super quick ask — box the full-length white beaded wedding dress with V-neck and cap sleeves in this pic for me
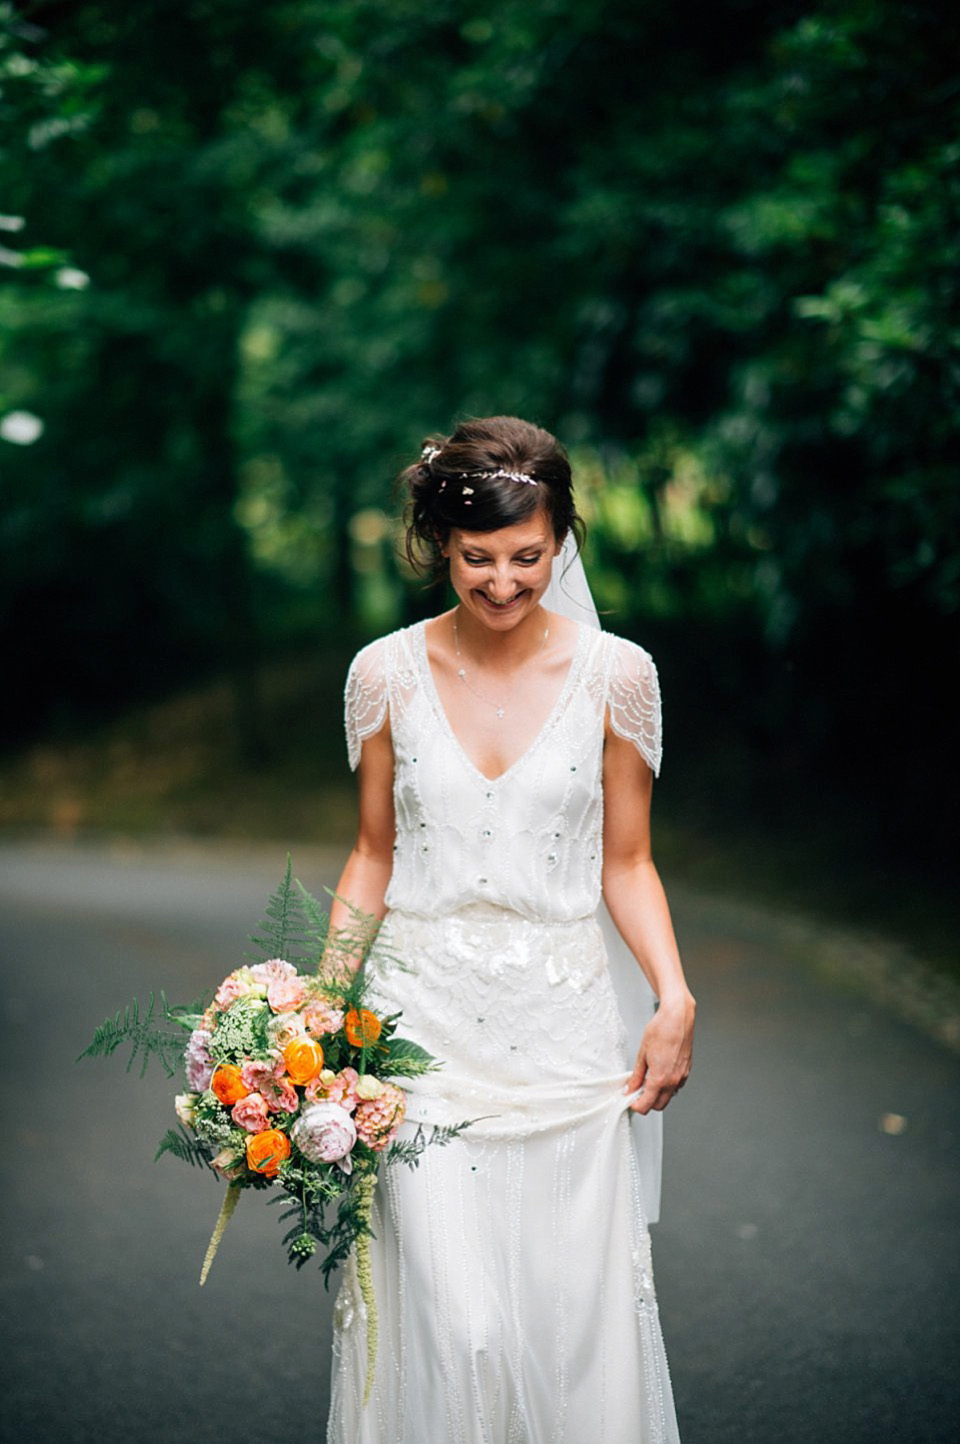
[328,622,678,1444]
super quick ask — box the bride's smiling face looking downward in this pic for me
[443,511,560,631]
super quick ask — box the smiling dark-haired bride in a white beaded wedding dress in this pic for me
[329,417,694,1444]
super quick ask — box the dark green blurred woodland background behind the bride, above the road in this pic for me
[0,0,960,959]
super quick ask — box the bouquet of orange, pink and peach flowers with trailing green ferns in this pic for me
[81,858,468,1395]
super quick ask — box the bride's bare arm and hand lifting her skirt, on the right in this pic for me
[603,728,696,1113]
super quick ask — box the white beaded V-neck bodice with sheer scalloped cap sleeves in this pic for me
[345,622,661,923]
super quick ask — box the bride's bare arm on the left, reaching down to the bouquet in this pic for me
[331,721,396,972]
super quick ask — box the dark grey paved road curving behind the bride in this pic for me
[0,846,960,1444]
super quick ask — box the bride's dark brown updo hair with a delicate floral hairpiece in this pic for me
[397,416,586,575]
